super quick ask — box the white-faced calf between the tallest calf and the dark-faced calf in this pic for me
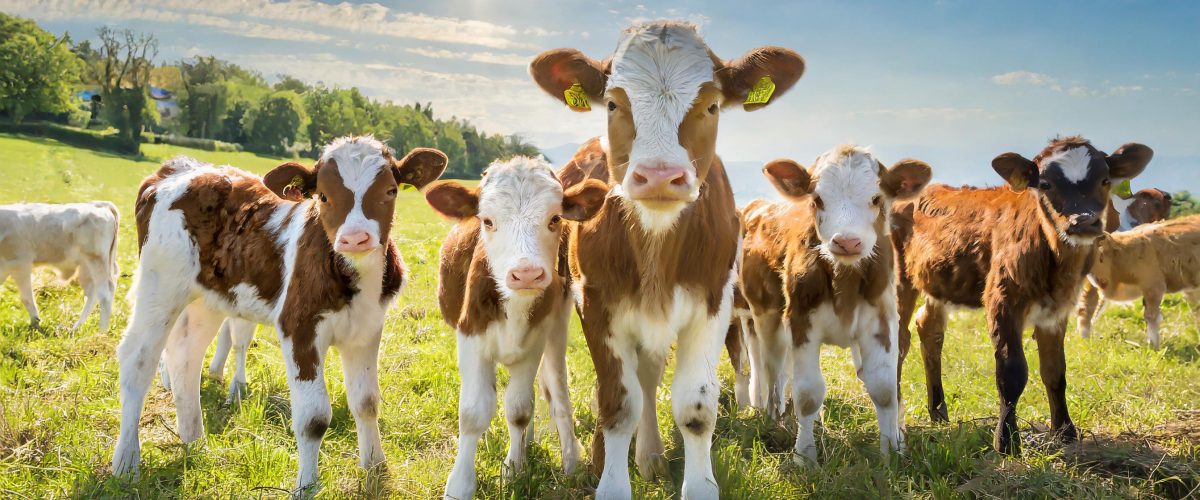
[740,145,932,460]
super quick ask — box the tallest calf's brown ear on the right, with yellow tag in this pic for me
[716,46,804,112]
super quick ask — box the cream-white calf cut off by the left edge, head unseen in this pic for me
[0,201,120,331]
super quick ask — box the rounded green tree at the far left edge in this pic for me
[0,12,82,124]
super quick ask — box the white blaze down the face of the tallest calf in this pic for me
[608,23,714,165]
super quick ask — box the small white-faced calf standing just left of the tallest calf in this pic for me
[425,157,608,499]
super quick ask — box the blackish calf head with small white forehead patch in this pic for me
[991,137,1154,245]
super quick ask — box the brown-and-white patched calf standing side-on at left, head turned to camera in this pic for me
[113,137,446,488]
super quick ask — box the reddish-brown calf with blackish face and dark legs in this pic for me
[894,137,1153,453]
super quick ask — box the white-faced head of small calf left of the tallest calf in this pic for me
[425,157,608,296]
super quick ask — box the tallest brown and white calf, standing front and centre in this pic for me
[529,22,804,499]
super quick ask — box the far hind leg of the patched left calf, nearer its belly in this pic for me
[166,300,223,444]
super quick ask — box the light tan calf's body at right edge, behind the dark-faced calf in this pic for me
[1078,216,1200,349]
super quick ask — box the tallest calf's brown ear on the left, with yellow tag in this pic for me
[529,49,608,112]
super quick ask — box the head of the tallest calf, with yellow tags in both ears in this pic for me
[529,20,804,231]
